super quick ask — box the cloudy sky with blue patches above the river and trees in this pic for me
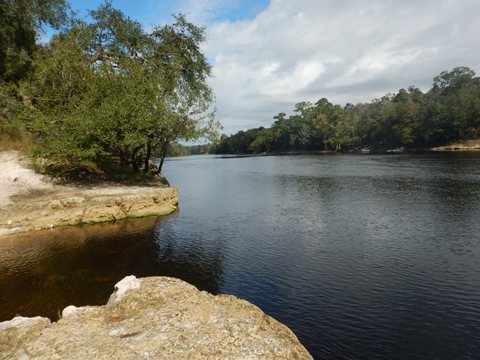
[66,0,480,134]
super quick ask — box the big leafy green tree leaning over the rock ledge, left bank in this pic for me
[21,3,218,172]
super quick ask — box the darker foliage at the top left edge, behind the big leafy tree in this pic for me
[0,0,69,152]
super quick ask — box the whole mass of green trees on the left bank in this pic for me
[0,0,219,172]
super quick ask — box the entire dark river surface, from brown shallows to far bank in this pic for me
[0,154,480,359]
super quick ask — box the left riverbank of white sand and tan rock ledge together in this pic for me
[0,152,178,236]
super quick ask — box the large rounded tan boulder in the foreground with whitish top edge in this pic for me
[0,276,312,359]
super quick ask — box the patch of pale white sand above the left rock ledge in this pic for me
[0,151,54,207]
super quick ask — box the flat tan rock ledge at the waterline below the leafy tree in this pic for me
[0,186,178,236]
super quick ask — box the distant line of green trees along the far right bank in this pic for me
[212,67,480,154]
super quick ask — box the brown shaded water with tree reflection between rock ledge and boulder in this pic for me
[0,218,222,321]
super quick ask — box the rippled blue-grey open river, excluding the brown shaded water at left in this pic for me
[166,154,480,359]
